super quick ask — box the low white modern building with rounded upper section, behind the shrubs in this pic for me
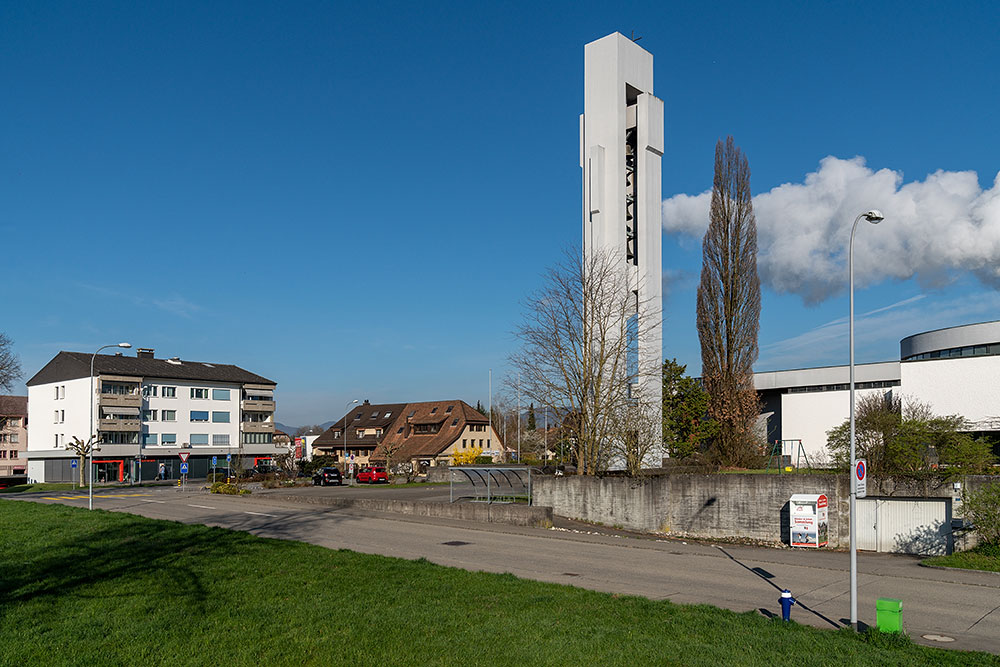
[754,321,1000,465]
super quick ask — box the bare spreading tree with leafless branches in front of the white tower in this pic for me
[508,251,661,474]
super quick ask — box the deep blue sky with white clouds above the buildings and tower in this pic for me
[0,2,1000,424]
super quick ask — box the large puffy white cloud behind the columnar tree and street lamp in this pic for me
[662,156,1000,303]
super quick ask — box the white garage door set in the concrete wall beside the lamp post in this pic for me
[858,498,953,555]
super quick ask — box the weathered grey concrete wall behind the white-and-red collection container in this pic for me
[532,474,997,547]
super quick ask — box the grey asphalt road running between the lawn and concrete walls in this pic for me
[9,486,1000,653]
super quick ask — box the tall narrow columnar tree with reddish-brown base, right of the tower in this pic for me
[697,137,760,466]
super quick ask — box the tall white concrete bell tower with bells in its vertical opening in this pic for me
[580,32,663,454]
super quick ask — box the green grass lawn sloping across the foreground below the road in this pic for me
[0,501,1000,666]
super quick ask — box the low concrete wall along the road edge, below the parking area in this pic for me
[267,493,552,528]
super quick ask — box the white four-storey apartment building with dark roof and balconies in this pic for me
[27,348,284,482]
